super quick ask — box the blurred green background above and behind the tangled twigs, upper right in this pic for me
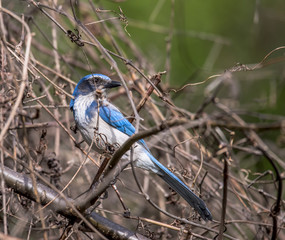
[96,0,285,115]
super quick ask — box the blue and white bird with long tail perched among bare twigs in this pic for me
[70,73,212,221]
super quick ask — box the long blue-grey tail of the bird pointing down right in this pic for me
[149,154,212,221]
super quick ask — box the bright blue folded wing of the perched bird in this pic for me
[99,104,149,151]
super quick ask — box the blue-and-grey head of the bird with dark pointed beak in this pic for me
[69,74,121,109]
